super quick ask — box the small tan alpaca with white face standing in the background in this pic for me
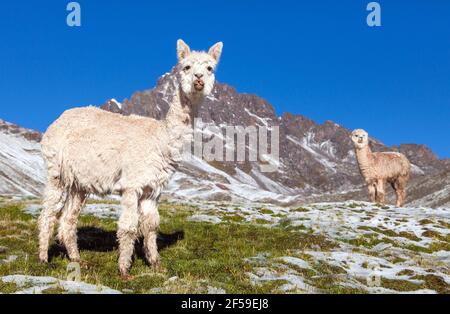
[351,129,411,207]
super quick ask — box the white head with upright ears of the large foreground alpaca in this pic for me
[177,39,223,101]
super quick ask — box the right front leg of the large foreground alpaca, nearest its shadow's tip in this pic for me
[140,198,160,267]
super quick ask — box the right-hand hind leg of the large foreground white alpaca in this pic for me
[58,191,86,262]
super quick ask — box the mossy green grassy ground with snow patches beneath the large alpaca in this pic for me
[0,199,450,293]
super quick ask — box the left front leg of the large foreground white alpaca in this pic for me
[117,191,139,277]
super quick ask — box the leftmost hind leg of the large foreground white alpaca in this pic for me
[38,180,67,263]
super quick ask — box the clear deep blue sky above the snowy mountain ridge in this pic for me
[0,0,450,157]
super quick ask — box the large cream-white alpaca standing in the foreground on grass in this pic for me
[39,40,223,278]
